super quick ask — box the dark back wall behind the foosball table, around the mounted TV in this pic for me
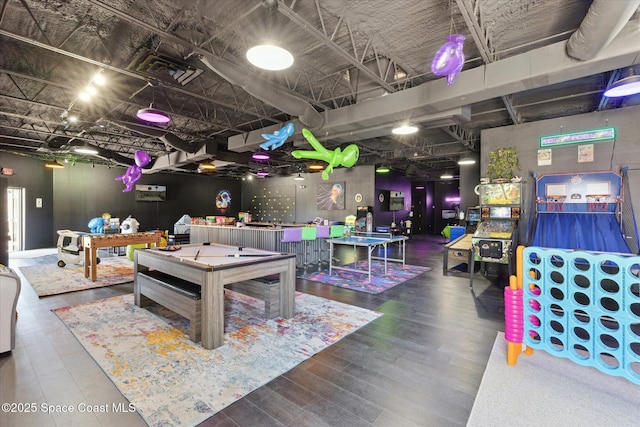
[53,164,242,239]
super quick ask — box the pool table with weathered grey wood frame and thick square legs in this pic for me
[134,243,296,350]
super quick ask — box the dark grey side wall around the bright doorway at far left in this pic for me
[0,153,54,249]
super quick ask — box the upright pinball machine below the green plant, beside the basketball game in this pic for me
[471,182,522,275]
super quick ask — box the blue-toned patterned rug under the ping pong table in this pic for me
[298,260,431,294]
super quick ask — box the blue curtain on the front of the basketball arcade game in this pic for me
[531,212,631,253]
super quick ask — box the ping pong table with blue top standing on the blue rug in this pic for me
[328,233,408,282]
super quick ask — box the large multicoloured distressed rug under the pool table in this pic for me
[54,290,382,426]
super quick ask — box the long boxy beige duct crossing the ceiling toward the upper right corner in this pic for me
[229,21,640,155]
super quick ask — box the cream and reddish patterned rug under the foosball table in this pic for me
[18,257,133,297]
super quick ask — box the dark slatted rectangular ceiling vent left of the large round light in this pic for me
[127,50,204,86]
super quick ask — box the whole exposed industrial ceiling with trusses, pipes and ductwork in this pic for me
[0,0,640,178]
